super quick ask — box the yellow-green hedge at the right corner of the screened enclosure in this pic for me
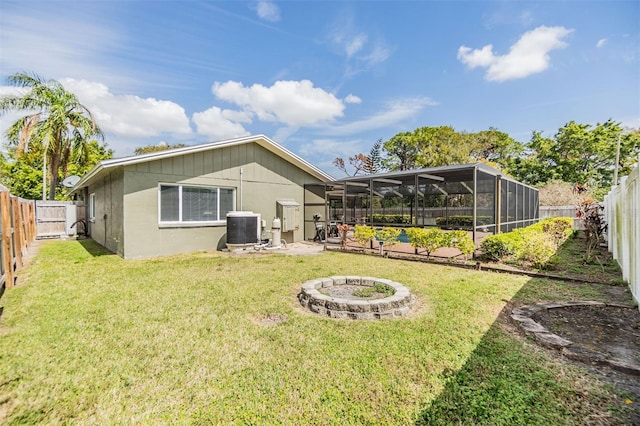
[480,217,573,269]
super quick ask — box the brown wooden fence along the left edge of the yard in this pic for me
[0,186,36,288]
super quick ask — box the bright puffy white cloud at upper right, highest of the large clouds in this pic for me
[458,26,573,81]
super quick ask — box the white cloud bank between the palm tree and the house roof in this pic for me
[60,78,192,137]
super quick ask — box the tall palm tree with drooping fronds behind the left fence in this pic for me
[0,73,104,200]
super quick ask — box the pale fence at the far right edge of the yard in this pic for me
[604,155,640,310]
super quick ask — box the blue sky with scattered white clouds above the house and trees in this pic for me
[0,0,640,177]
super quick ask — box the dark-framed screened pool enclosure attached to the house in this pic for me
[304,163,539,241]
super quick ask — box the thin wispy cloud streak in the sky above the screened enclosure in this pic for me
[327,98,438,135]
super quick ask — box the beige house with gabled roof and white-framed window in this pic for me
[72,135,333,259]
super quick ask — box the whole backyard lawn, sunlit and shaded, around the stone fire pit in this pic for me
[0,241,632,425]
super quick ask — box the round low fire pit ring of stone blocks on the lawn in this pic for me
[298,276,415,319]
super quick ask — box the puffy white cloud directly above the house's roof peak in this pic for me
[211,80,344,127]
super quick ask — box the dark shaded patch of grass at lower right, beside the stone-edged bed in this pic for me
[416,279,633,425]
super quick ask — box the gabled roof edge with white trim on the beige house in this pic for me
[71,135,334,192]
